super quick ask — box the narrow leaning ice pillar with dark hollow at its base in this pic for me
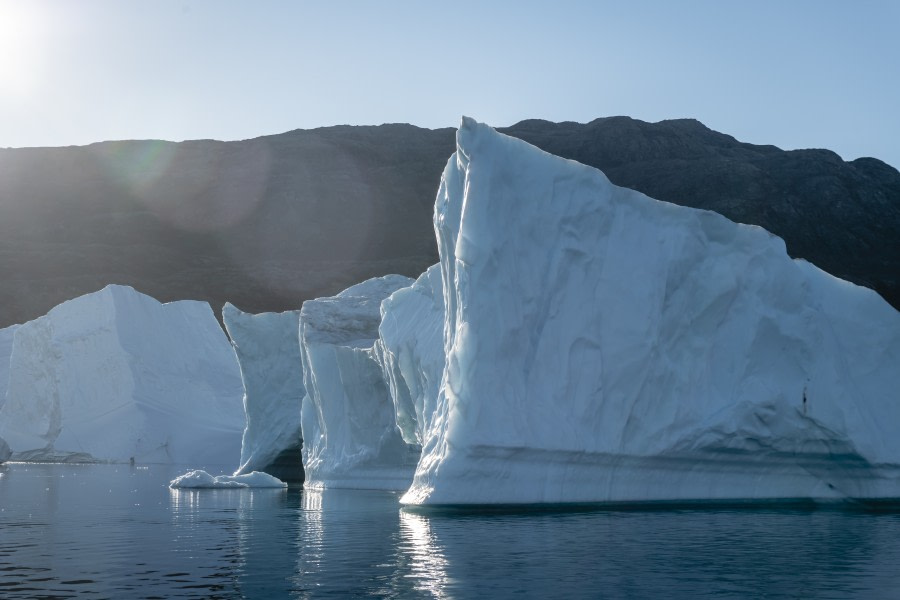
[222,304,305,479]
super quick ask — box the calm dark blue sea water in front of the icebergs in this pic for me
[0,464,900,599]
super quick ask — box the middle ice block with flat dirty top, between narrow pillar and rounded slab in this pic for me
[300,275,418,490]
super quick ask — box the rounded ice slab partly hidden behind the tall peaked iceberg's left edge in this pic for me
[374,265,444,446]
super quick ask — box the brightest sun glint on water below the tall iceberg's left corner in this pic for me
[400,511,449,598]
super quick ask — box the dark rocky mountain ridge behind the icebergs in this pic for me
[0,117,900,327]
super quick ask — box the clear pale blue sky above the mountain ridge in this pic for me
[0,0,900,167]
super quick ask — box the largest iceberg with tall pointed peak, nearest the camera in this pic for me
[402,118,900,504]
